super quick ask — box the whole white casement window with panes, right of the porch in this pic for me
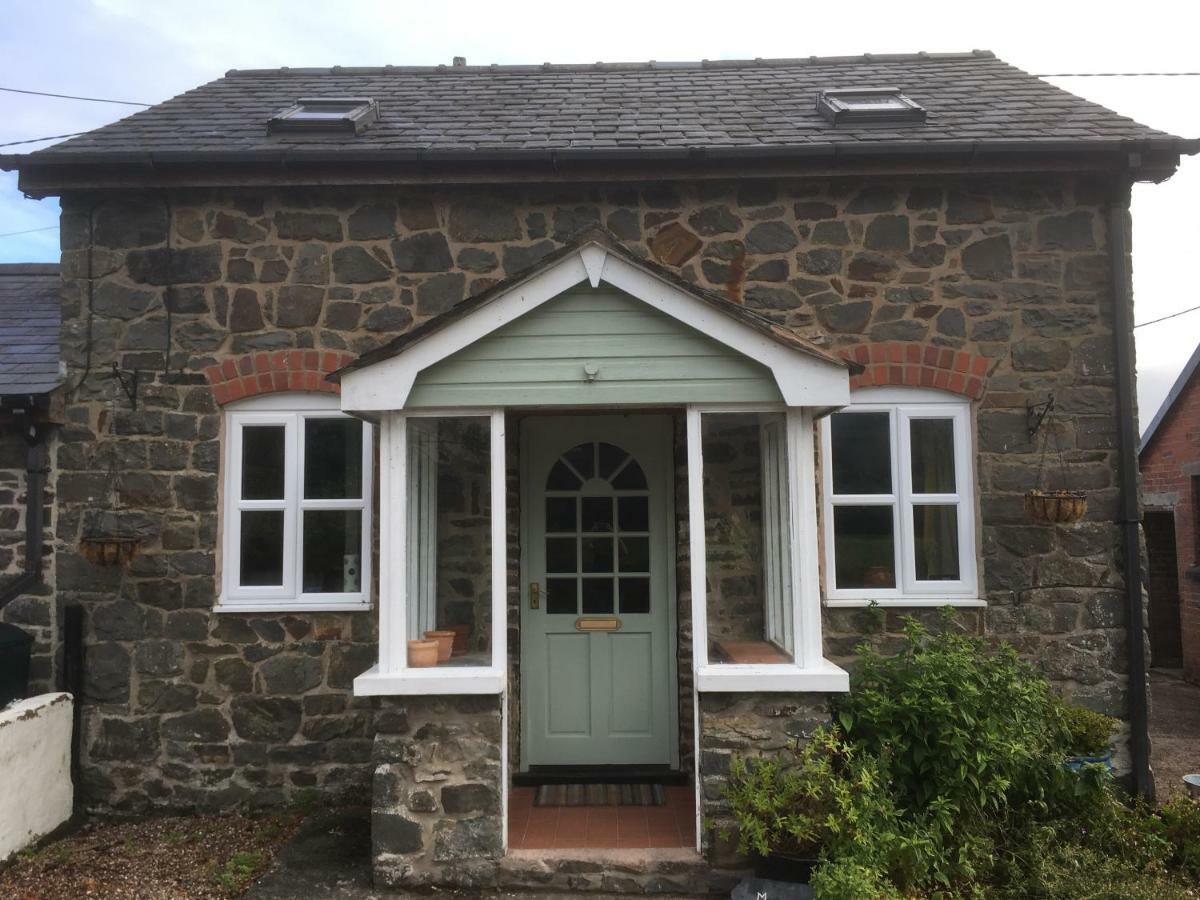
[822,388,982,606]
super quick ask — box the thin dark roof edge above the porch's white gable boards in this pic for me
[326,228,863,382]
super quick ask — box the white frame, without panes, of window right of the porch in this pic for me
[821,388,986,607]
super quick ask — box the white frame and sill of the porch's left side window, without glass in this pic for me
[354,408,508,696]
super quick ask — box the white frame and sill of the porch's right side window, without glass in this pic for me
[686,404,850,692]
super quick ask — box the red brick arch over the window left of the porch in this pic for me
[204,350,355,406]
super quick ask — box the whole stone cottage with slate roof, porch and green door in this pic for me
[2,53,1198,890]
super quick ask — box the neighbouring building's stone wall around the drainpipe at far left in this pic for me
[0,425,59,696]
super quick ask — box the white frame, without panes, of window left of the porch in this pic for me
[216,392,374,612]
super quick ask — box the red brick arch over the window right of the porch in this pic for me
[838,341,996,400]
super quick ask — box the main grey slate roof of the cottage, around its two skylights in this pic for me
[0,50,1200,168]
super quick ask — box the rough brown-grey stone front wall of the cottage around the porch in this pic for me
[46,175,1124,873]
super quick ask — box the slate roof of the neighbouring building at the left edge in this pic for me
[0,263,61,395]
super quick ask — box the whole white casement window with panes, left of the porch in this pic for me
[218,394,372,612]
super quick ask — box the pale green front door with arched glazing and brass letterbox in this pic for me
[521,415,677,768]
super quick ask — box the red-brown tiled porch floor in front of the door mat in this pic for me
[509,786,696,850]
